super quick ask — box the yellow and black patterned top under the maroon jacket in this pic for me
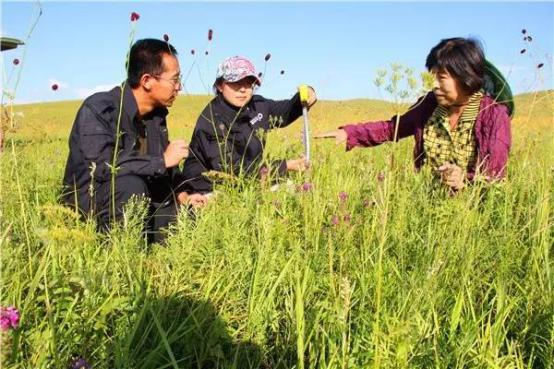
[423,91,483,171]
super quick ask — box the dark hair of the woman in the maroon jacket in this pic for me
[425,37,485,94]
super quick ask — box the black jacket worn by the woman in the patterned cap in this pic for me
[183,94,302,193]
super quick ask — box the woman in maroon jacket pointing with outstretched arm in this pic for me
[315,38,513,190]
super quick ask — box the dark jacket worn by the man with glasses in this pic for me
[63,87,181,212]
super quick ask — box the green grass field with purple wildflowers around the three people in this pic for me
[0,91,554,369]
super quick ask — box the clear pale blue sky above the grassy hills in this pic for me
[0,1,554,103]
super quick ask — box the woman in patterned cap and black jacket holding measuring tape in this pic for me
[183,56,316,193]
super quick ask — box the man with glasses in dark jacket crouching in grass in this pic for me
[63,39,206,241]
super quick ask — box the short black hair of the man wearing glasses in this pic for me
[127,38,177,88]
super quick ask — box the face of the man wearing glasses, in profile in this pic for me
[150,54,183,107]
